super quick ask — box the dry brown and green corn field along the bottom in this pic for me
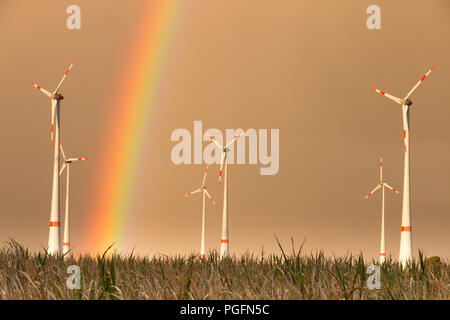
[0,240,450,300]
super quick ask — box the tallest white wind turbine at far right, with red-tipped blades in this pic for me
[372,66,436,267]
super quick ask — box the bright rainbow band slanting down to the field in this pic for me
[82,0,182,253]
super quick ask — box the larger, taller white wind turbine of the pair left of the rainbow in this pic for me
[31,60,75,255]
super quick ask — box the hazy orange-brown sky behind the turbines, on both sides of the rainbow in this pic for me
[0,0,450,258]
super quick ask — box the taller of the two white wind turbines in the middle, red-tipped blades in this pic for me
[204,130,248,257]
